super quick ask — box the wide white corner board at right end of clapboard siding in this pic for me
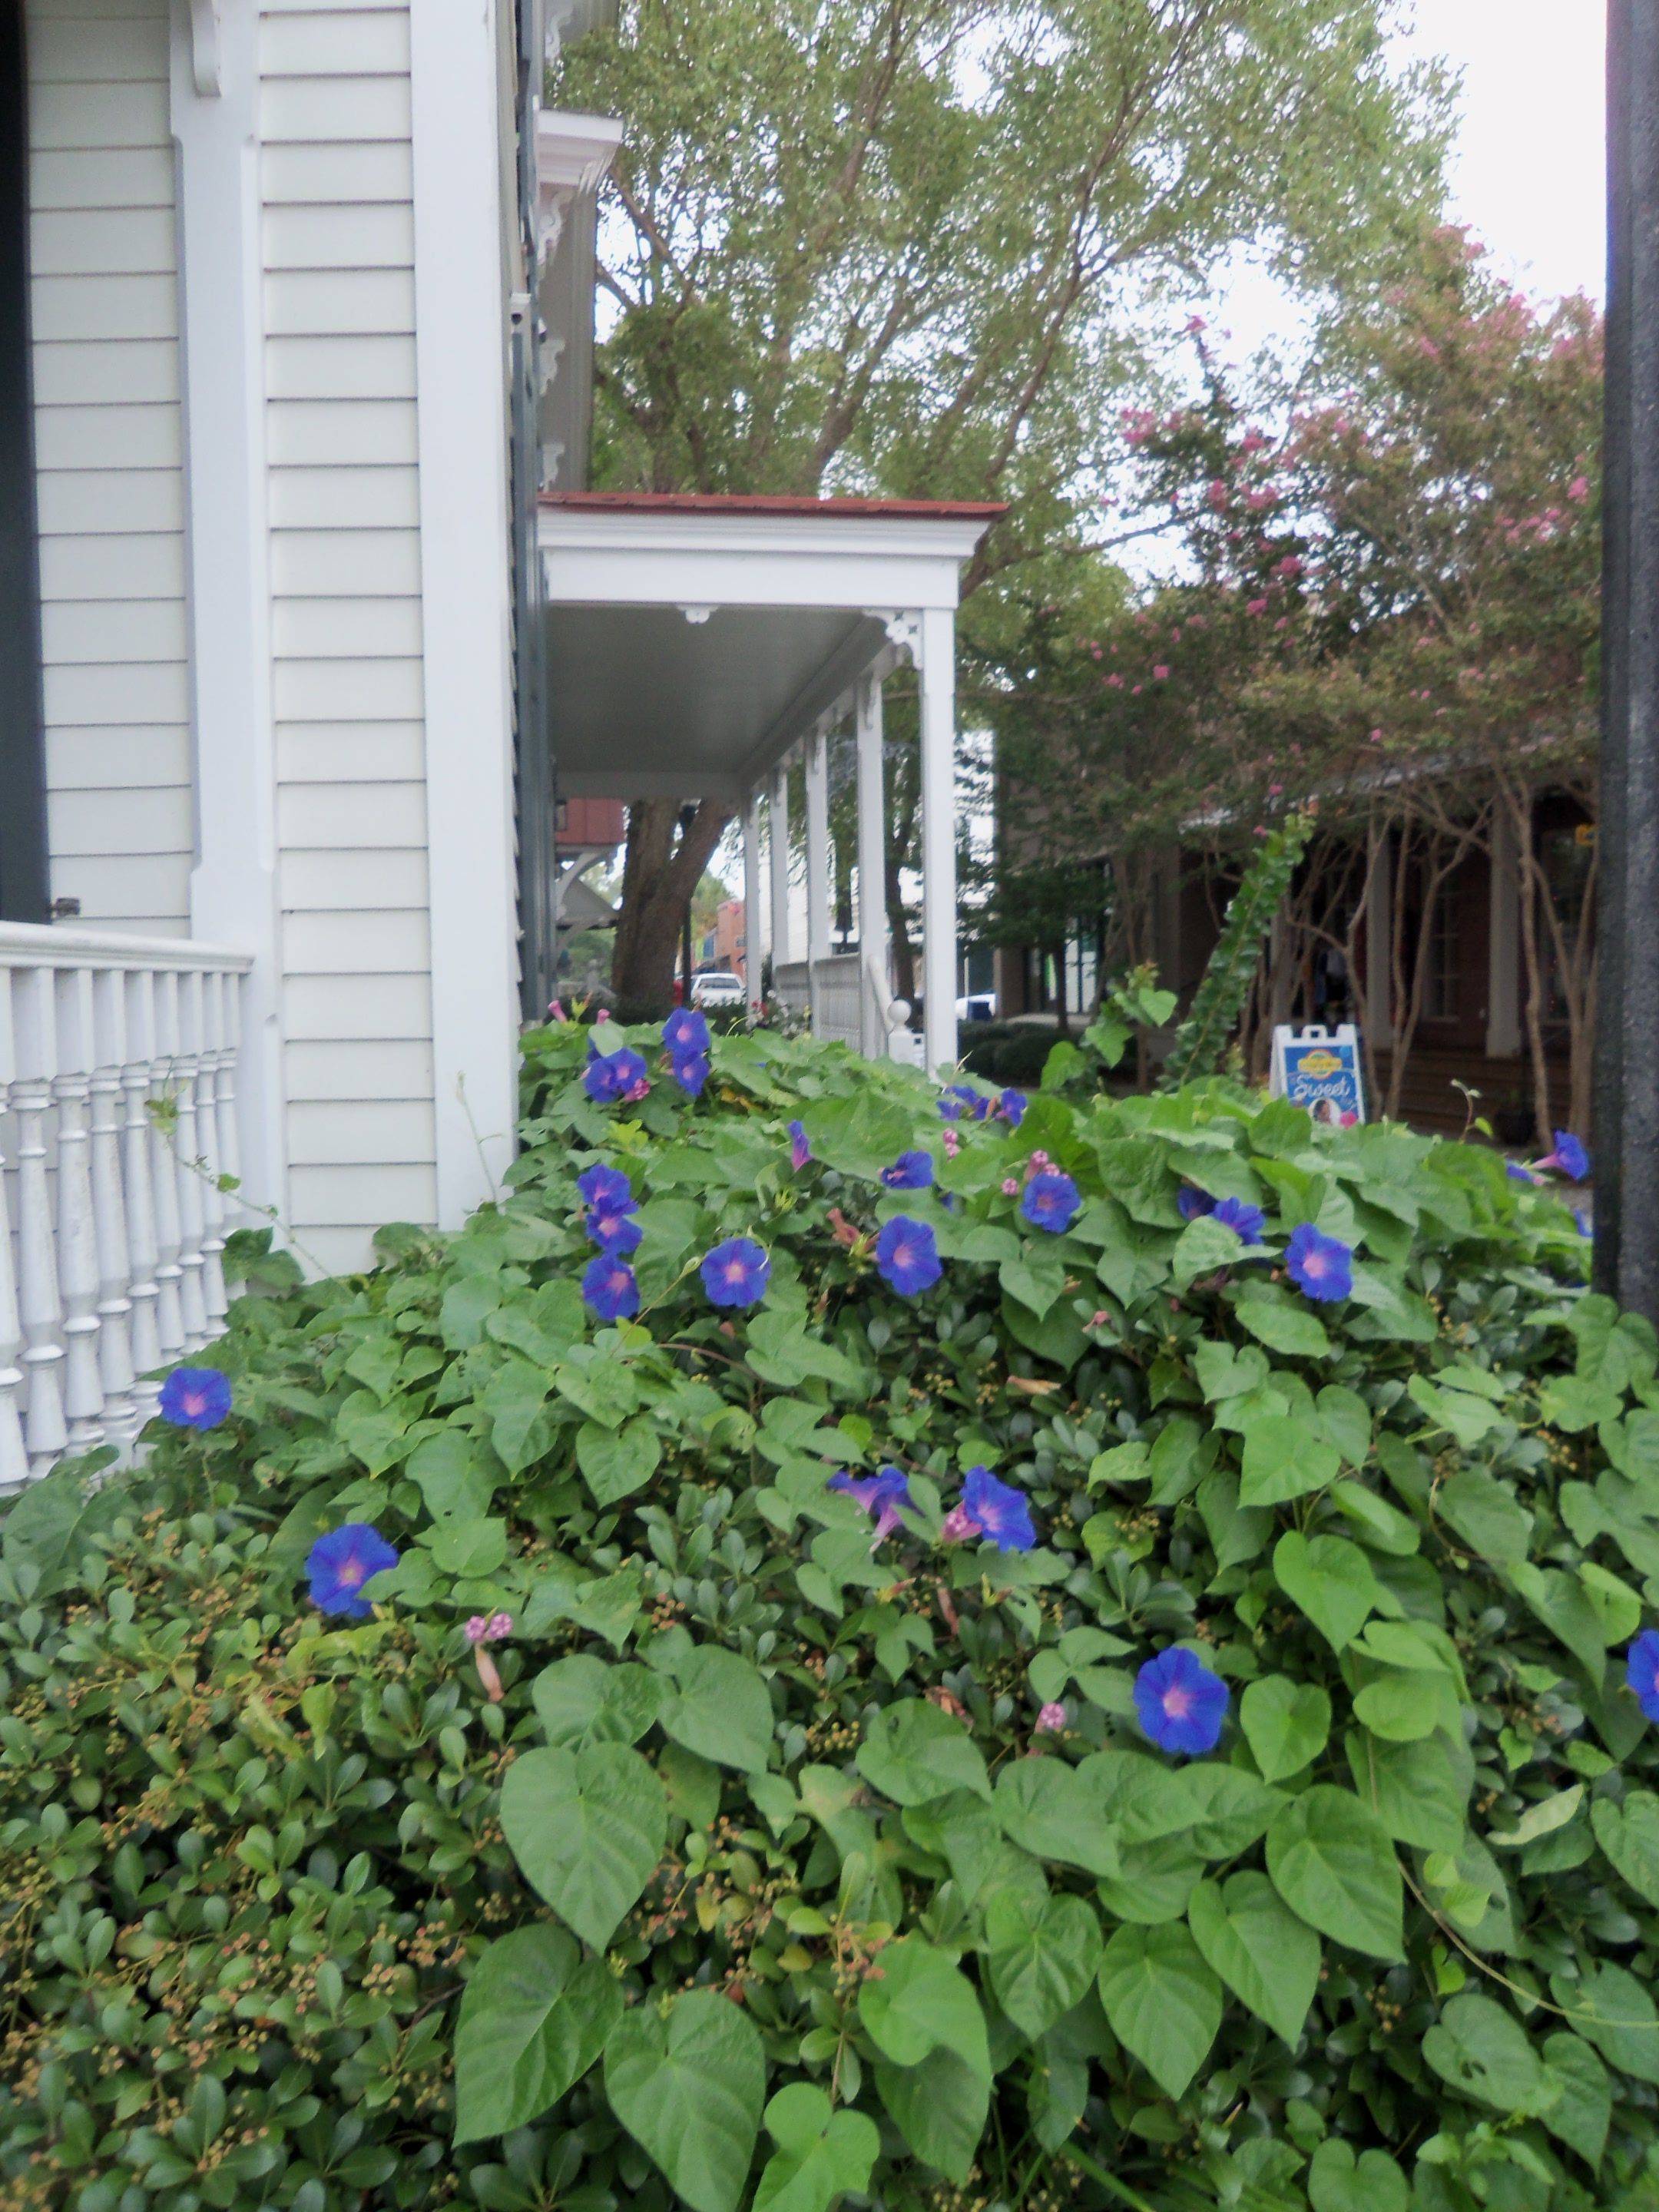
[409,0,518,1227]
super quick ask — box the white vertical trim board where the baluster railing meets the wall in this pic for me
[171,7,287,1219]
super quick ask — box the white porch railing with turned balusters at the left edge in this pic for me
[0,922,250,1495]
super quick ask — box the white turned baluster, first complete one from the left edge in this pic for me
[11,969,68,1475]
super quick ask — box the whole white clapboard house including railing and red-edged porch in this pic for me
[0,0,993,1488]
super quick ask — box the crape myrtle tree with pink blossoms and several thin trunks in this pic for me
[993,228,1601,1128]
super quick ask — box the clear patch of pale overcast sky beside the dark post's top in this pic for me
[1400,0,1606,299]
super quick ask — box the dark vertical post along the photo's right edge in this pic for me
[1594,0,1659,1320]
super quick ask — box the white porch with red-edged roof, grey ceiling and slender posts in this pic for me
[538,491,1002,1068]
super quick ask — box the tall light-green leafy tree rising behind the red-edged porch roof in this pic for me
[553,0,1445,998]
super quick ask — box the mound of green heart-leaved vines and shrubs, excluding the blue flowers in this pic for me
[0,1026,1659,2212]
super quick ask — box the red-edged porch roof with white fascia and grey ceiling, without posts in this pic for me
[540,493,1000,803]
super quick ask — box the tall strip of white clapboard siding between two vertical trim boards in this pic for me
[259,0,438,1267]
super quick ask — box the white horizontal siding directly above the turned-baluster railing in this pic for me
[25,0,194,935]
